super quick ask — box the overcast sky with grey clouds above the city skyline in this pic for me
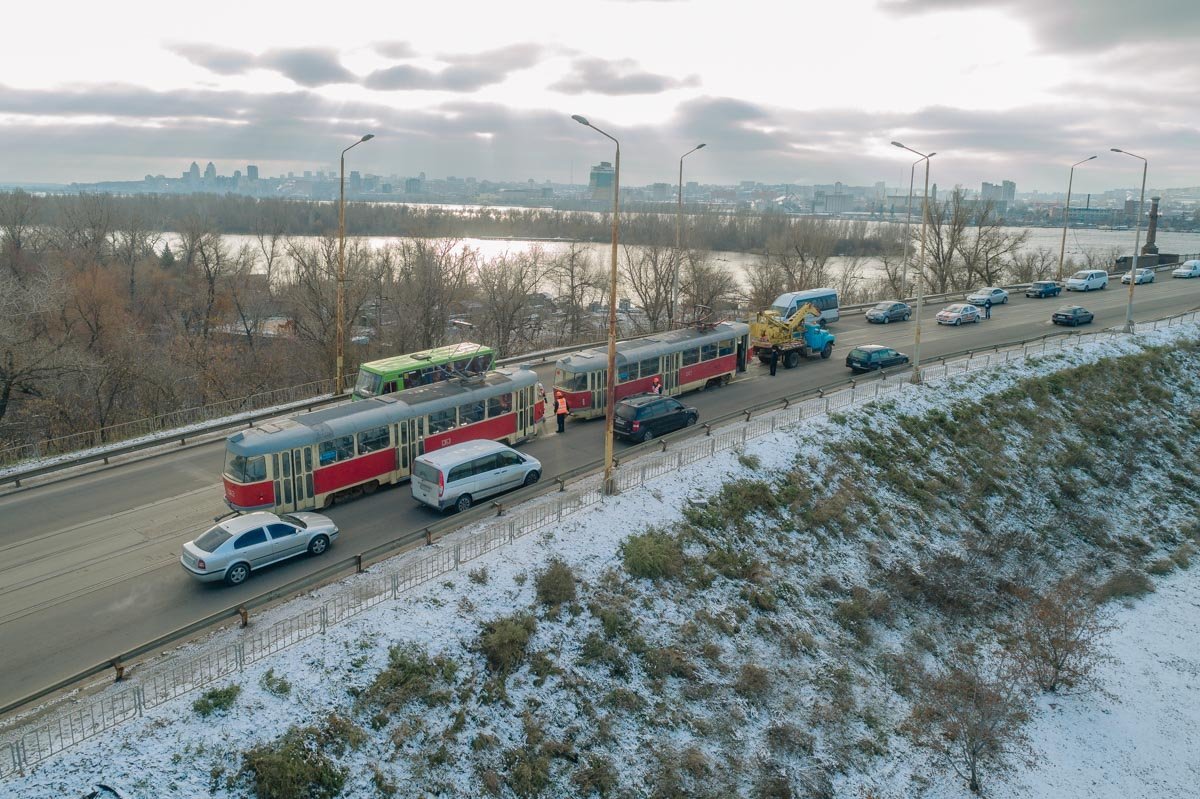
[0,0,1200,192]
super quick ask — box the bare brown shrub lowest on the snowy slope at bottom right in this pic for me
[908,645,1031,793]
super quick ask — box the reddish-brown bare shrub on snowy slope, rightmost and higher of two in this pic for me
[1010,576,1112,693]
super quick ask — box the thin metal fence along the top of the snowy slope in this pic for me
[0,305,1200,777]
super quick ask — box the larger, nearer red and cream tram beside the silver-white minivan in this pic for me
[222,367,545,512]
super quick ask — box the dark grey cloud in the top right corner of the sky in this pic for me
[880,0,1200,53]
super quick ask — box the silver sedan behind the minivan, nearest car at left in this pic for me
[179,511,337,585]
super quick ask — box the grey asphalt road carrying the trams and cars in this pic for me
[0,275,1200,705]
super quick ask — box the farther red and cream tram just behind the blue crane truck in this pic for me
[554,322,750,419]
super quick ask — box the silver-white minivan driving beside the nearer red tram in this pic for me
[412,439,541,511]
